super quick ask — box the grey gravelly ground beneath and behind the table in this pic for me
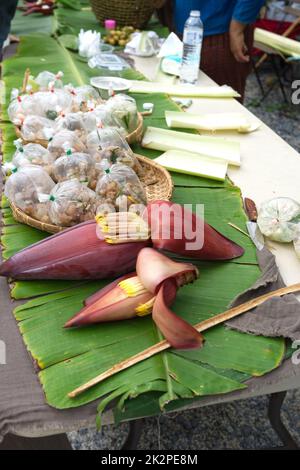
[69,60,300,450]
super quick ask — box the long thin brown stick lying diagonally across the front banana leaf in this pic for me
[68,283,300,398]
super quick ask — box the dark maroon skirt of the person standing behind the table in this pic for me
[201,28,253,102]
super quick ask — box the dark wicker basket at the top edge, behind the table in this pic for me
[91,0,166,28]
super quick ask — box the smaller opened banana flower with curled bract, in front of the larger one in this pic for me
[65,248,203,349]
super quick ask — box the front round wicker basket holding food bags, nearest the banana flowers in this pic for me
[11,155,173,233]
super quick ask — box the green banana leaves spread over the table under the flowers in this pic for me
[1,34,285,421]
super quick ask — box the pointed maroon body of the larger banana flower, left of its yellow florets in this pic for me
[0,221,150,280]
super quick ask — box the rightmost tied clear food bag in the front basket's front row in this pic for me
[96,163,147,212]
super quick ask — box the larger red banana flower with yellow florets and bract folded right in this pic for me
[0,201,244,280]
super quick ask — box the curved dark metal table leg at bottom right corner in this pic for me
[268,392,299,449]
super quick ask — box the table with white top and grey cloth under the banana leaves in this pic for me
[0,53,300,449]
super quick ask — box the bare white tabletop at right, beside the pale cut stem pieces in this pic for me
[134,57,300,288]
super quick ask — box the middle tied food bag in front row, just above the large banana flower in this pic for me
[39,180,96,227]
